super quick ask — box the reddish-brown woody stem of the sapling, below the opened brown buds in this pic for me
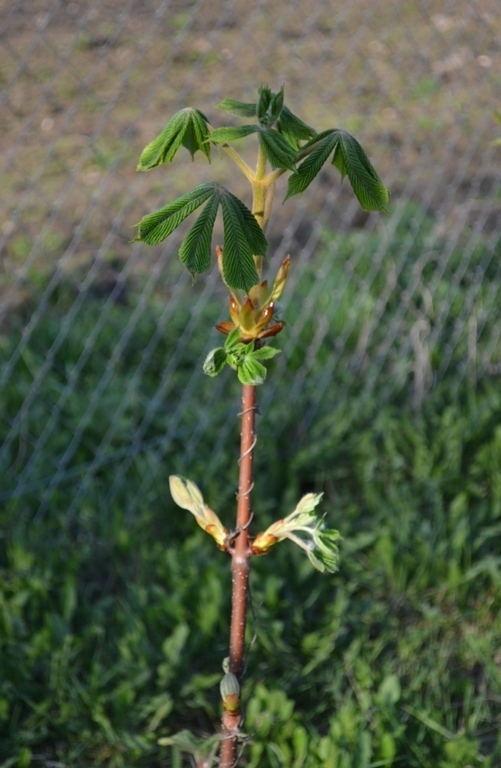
[219,384,257,768]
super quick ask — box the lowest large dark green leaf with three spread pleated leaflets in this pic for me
[135,182,268,291]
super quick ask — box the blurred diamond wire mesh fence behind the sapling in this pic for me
[0,0,501,517]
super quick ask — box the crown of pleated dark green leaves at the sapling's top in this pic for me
[136,86,389,291]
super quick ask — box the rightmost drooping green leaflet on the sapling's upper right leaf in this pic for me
[332,130,390,211]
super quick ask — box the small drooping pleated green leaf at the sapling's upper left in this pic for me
[137,107,210,171]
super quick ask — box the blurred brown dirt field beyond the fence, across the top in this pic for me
[0,0,501,313]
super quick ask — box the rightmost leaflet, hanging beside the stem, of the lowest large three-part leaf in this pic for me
[221,187,268,291]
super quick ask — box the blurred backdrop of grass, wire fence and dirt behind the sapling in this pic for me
[0,0,501,768]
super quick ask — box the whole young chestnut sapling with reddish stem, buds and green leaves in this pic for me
[136,86,389,768]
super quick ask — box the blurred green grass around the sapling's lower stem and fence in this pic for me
[0,210,501,768]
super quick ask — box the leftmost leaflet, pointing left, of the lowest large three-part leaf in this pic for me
[133,183,213,245]
